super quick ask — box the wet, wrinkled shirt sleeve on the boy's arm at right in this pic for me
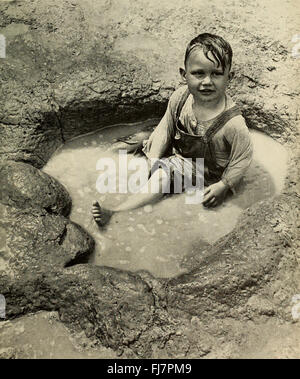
[222,116,253,192]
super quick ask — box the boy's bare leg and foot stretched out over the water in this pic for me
[92,168,169,225]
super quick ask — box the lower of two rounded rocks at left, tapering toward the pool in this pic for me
[0,205,94,280]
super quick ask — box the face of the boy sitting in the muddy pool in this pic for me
[180,48,232,102]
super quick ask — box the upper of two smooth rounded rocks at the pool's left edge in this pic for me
[0,161,71,216]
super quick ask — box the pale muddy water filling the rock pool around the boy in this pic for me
[44,120,287,277]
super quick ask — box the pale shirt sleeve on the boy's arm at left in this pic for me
[143,87,185,158]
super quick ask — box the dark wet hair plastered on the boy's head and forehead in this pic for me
[184,33,232,71]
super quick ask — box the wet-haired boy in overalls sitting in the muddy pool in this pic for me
[92,33,253,225]
